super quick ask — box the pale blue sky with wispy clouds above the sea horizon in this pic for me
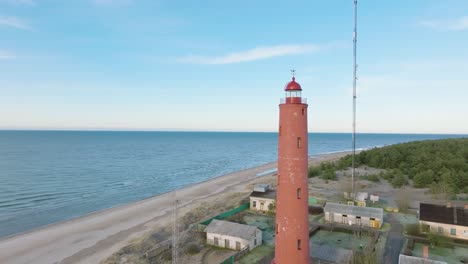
[0,0,468,134]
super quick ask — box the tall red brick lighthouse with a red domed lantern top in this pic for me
[274,71,310,264]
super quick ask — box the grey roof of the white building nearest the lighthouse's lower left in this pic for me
[205,219,258,240]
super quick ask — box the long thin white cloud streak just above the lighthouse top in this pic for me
[176,44,320,65]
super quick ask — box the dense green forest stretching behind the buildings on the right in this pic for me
[309,138,468,194]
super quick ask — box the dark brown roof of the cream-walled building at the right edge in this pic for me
[419,203,468,226]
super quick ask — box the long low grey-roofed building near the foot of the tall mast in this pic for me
[323,203,383,228]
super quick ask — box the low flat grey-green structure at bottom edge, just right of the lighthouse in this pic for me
[310,243,353,264]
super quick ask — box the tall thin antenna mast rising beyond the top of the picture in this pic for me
[351,0,357,200]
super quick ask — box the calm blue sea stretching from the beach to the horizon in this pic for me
[0,131,464,237]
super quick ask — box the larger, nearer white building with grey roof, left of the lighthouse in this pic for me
[205,219,262,251]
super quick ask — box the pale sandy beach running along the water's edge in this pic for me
[0,152,349,263]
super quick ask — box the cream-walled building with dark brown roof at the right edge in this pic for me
[419,203,468,240]
